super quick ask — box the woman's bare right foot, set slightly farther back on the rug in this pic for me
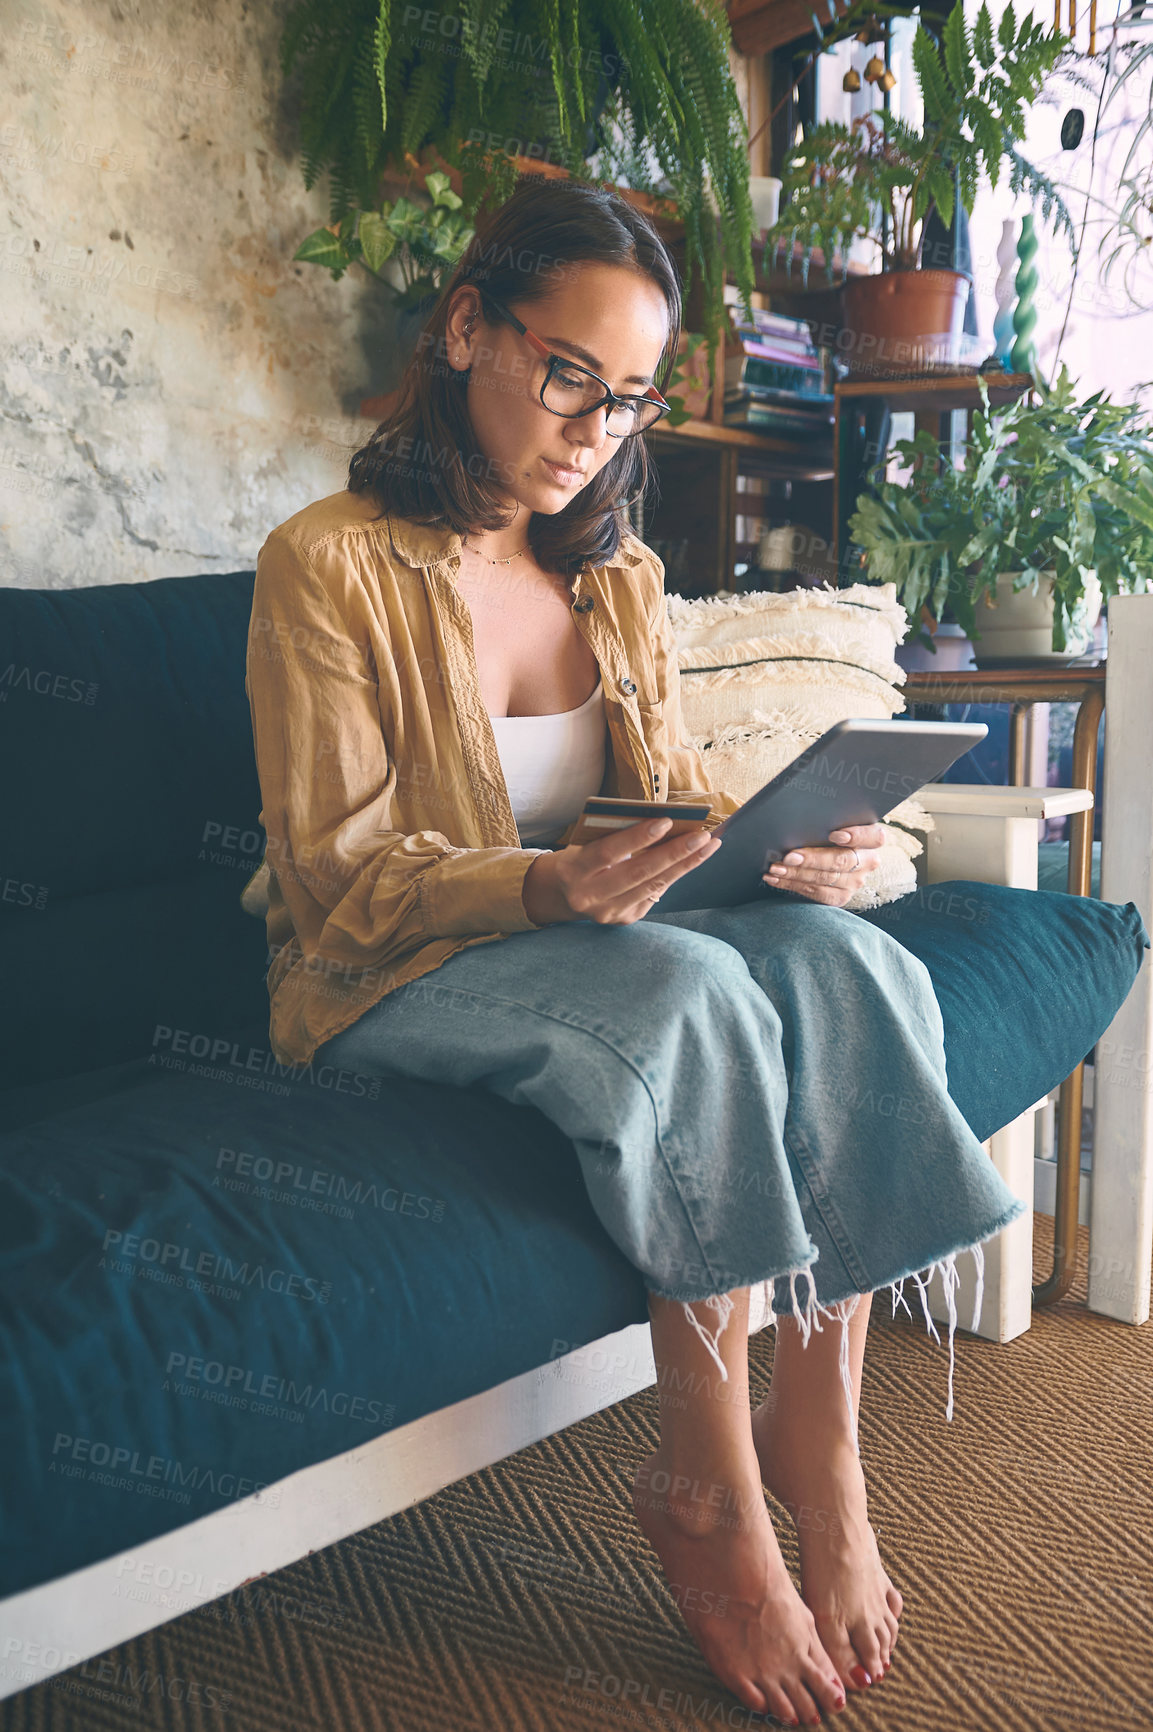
[753,1398,904,1690]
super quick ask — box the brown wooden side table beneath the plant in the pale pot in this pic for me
[902,662,1106,1306]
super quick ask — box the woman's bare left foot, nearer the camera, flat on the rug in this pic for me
[632,1448,845,1725]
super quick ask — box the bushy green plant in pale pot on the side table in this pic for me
[848,367,1153,667]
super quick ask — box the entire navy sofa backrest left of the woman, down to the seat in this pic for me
[0,572,268,1089]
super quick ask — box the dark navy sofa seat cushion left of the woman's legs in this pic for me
[0,1029,647,1597]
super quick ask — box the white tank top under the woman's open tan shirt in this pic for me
[488,679,606,849]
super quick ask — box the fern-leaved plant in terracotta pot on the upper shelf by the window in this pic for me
[767,0,1073,371]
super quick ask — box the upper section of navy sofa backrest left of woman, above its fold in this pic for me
[0,572,263,923]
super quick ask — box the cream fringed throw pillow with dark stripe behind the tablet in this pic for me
[667,584,935,909]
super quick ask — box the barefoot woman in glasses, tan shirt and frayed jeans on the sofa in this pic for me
[248,172,1021,1725]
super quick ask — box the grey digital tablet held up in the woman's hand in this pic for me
[642,717,989,920]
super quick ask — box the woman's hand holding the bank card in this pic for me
[521,818,720,927]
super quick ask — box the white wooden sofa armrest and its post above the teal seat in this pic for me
[918,781,1092,890]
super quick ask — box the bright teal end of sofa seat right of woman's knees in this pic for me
[853,878,1150,1141]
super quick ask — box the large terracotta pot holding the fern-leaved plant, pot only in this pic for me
[841,270,969,378]
